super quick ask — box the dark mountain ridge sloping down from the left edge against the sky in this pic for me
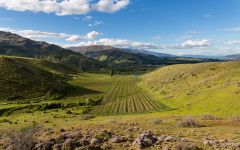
[0,31,103,70]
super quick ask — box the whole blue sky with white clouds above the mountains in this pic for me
[0,0,240,55]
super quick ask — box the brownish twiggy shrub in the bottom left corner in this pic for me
[6,124,41,150]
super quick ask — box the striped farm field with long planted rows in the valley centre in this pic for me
[93,76,166,115]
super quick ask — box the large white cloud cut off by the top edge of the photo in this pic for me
[0,0,130,16]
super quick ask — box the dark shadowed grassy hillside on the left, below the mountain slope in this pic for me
[0,56,74,100]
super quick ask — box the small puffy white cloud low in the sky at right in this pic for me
[170,39,212,49]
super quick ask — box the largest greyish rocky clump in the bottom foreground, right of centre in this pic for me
[133,131,157,148]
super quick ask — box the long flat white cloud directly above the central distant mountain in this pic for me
[64,38,163,49]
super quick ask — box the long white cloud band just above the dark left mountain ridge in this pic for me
[0,27,100,42]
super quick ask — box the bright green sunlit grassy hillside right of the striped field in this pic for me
[142,61,240,116]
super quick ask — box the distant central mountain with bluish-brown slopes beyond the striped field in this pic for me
[69,45,218,69]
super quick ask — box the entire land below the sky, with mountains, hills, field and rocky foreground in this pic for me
[0,32,240,150]
